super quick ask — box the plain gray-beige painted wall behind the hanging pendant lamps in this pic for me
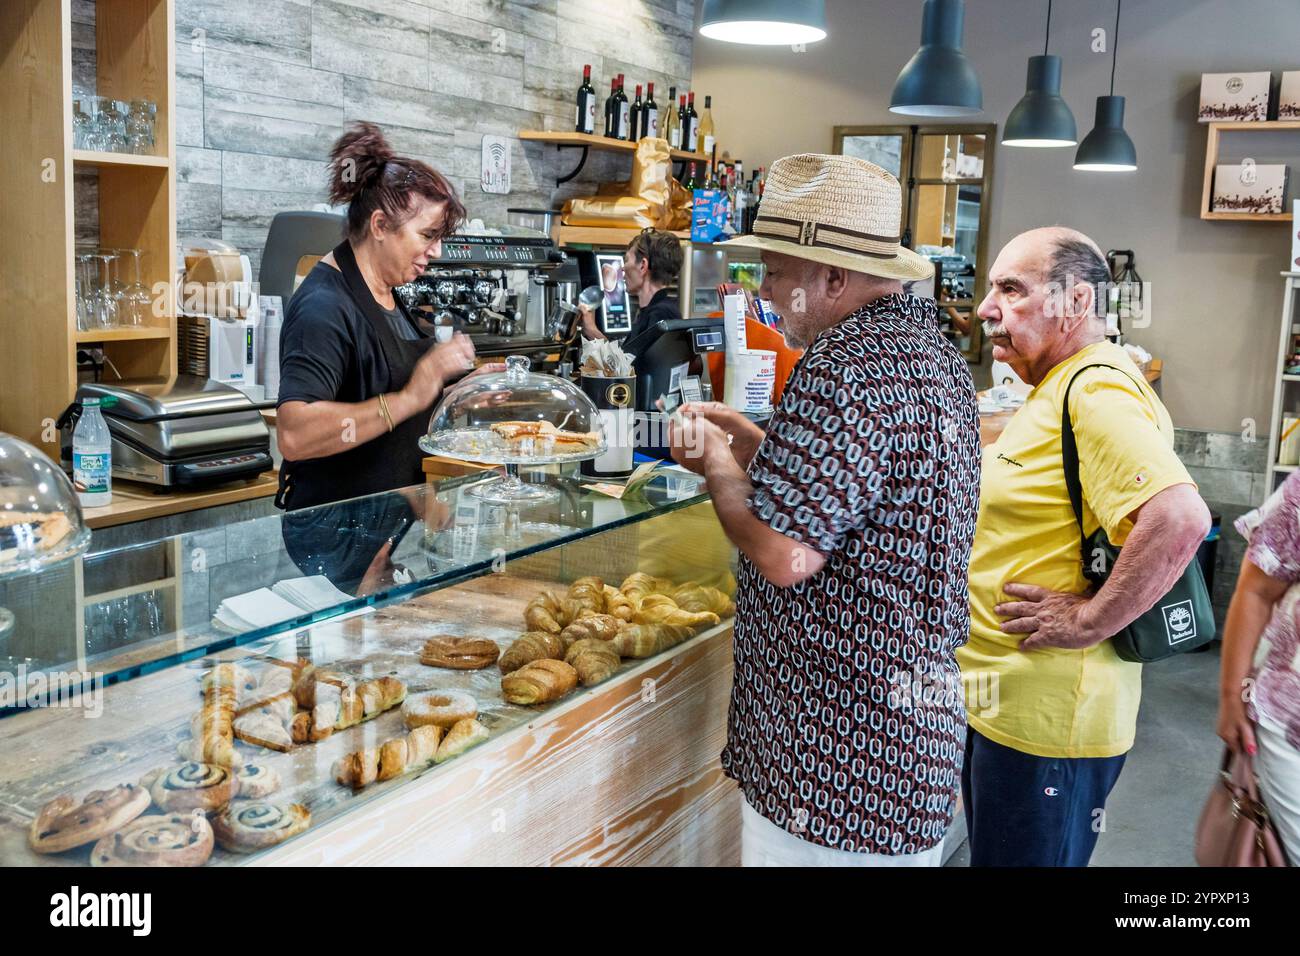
[694,0,1300,434]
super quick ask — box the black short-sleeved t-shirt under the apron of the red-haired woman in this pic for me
[277,263,428,405]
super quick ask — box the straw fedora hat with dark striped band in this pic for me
[727,152,935,282]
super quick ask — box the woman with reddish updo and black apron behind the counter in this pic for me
[276,122,503,510]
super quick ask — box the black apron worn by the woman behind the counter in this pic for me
[276,239,437,510]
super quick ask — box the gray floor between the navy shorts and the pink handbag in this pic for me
[948,644,1222,866]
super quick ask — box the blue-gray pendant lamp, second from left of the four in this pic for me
[889,0,984,116]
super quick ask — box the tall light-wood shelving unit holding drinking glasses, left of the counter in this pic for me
[0,0,176,458]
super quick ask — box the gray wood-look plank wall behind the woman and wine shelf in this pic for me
[73,0,694,274]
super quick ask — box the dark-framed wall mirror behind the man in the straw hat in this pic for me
[835,124,996,362]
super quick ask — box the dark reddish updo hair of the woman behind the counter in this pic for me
[329,122,465,241]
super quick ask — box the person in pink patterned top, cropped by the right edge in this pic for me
[1218,472,1300,866]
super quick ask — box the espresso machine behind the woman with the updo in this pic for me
[397,226,577,355]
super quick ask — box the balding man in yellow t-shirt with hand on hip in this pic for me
[957,228,1210,866]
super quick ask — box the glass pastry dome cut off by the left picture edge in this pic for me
[0,432,90,636]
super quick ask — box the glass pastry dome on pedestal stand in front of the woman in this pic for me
[420,355,606,502]
